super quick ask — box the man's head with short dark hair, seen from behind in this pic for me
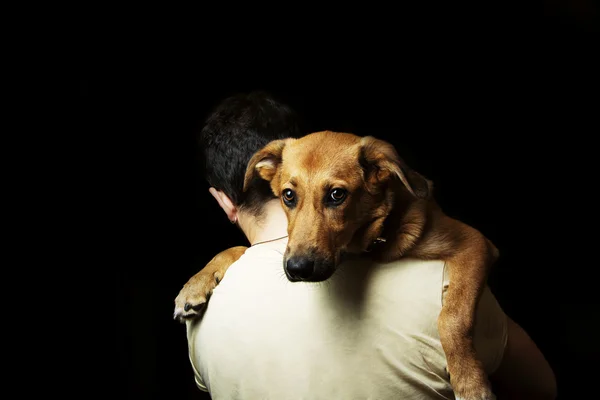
[198,92,300,222]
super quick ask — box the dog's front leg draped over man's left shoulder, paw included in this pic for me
[173,246,247,322]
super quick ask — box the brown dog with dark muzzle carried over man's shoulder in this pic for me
[175,131,498,400]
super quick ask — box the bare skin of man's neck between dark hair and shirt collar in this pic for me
[238,200,287,245]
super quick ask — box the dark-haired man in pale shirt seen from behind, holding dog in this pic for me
[187,93,556,400]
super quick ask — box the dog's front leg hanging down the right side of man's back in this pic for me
[438,236,497,400]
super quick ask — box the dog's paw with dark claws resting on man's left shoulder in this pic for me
[173,270,222,323]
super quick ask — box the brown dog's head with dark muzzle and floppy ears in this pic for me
[244,131,430,282]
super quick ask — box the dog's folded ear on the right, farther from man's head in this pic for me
[359,136,432,199]
